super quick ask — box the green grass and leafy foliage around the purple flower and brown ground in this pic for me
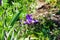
[0,0,60,40]
